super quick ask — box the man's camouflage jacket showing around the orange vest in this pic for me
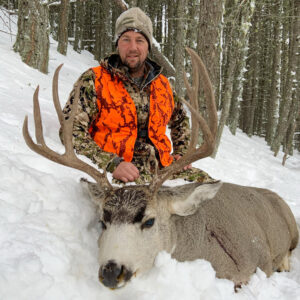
[60,54,190,173]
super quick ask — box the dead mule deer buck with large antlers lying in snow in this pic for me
[23,49,298,288]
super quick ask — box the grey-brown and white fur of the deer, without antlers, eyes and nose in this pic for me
[84,182,298,287]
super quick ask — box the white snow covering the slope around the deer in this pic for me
[0,10,300,300]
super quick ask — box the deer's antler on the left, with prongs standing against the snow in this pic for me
[23,65,113,189]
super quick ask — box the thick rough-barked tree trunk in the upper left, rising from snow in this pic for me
[14,0,49,73]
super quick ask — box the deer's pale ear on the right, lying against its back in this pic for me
[169,181,222,216]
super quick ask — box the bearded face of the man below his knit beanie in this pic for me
[118,31,148,74]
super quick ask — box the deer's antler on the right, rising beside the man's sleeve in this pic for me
[149,48,218,192]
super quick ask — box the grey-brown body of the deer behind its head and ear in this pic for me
[172,183,298,284]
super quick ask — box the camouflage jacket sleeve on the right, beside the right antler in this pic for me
[169,93,191,155]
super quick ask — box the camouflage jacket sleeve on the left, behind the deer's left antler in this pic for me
[60,69,117,171]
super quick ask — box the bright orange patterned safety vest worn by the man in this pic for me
[89,66,174,166]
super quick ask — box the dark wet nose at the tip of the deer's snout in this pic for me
[99,261,132,289]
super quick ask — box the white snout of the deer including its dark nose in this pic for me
[98,224,160,288]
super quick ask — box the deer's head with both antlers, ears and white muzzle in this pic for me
[23,49,220,288]
